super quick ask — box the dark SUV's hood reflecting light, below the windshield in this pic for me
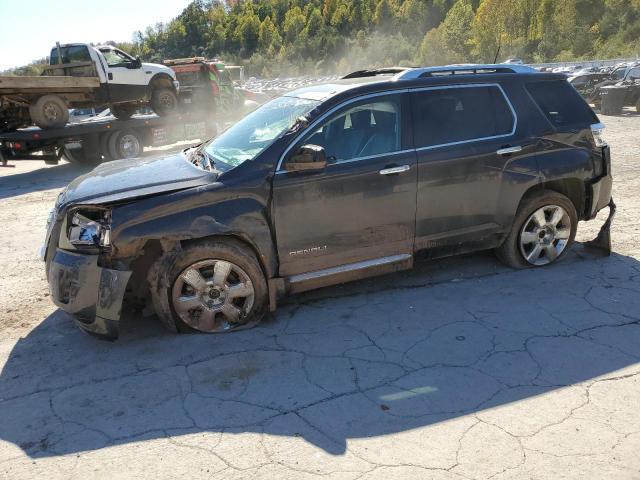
[56,153,212,206]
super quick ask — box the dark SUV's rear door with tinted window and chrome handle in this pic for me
[411,84,524,254]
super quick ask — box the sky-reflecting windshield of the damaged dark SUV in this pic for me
[204,97,319,170]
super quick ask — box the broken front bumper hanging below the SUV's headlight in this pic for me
[49,248,131,340]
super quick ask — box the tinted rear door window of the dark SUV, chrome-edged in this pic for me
[411,86,515,148]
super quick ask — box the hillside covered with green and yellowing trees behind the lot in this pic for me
[5,0,640,76]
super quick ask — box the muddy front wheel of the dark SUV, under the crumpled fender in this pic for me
[148,239,268,333]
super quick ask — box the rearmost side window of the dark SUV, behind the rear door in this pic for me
[526,80,598,128]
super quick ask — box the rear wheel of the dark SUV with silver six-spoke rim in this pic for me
[495,190,578,269]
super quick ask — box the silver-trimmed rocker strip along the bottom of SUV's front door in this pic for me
[285,253,413,293]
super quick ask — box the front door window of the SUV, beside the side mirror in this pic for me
[299,95,401,163]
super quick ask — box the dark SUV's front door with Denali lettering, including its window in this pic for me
[273,94,417,277]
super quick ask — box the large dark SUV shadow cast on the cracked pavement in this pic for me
[0,245,640,460]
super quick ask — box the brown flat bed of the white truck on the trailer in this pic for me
[0,75,100,95]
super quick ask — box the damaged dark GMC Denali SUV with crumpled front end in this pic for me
[42,65,614,338]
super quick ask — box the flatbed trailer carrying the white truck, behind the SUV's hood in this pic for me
[0,114,217,166]
